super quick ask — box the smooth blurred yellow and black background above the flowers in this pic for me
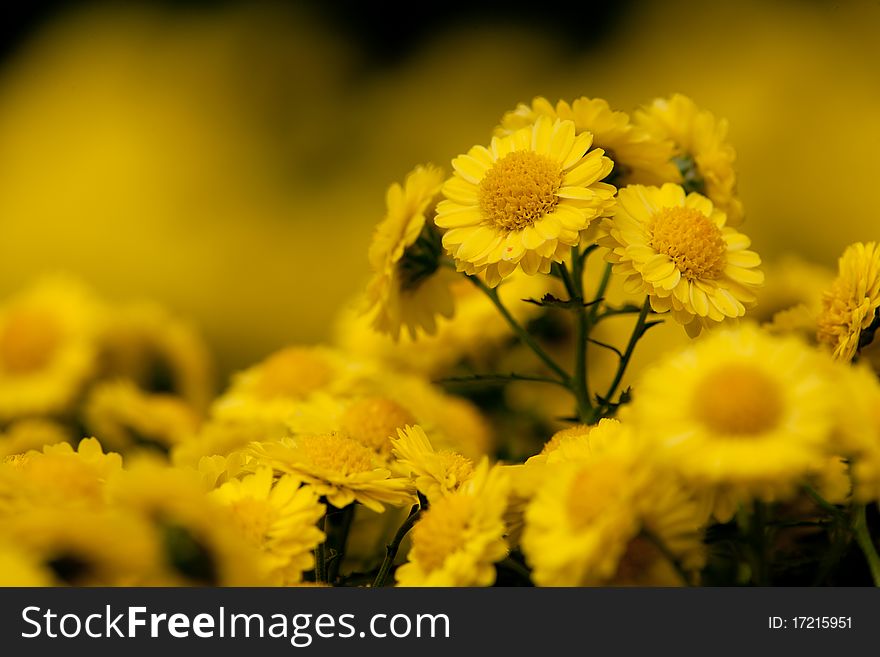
[0,0,880,380]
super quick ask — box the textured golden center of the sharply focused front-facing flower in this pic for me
[479,151,562,231]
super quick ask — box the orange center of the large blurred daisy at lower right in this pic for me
[693,363,783,436]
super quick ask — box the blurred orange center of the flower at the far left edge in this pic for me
[0,310,62,374]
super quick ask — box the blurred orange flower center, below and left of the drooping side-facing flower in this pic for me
[256,347,333,399]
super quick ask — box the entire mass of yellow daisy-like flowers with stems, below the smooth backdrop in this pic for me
[0,95,880,586]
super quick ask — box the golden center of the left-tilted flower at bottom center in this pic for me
[412,496,473,570]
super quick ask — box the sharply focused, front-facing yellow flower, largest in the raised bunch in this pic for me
[435,117,615,287]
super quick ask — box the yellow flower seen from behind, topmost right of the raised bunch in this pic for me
[633,94,743,226]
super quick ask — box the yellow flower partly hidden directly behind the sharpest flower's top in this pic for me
[495,96,681,187]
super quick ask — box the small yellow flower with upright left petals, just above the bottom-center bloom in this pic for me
[392,426,474,502]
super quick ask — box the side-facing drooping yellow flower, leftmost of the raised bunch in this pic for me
[366,166,454,340]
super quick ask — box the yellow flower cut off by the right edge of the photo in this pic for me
[817,242,880,362]
